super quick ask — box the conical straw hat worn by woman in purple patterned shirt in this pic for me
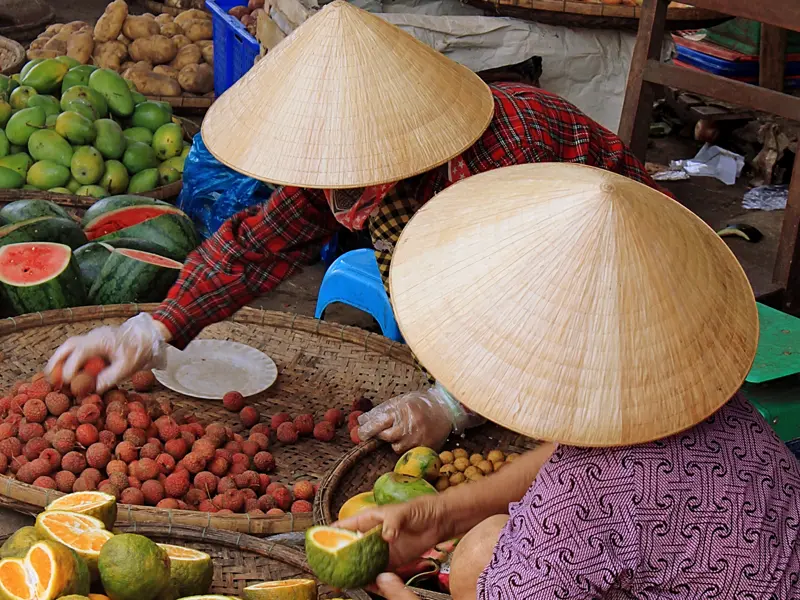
[390,164,758,446]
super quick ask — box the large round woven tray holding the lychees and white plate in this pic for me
[0,304,425,535]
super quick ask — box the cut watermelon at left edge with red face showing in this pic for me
[0,242,86,315]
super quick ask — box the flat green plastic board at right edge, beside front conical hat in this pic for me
[746,304,800,383]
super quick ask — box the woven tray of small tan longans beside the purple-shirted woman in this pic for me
[314,424,537,600]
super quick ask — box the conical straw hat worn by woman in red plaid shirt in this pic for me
[202,0,494,189]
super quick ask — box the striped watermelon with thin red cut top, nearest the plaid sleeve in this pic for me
[89,248,183,304]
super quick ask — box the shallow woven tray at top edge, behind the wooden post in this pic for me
[466,0,731,30]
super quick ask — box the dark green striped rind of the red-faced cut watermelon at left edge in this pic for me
[0,242,86,315]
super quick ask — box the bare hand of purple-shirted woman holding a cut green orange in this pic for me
[334,496,452,569]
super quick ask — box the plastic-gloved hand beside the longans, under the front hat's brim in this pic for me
[358,383,483,454]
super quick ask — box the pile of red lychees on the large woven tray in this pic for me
[0,358,319,516]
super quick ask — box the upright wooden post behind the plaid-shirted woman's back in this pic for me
[619,0,669,162]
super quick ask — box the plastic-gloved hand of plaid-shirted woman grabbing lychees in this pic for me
[45,313,169,394]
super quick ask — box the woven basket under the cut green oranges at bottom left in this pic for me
[0,523,369,600]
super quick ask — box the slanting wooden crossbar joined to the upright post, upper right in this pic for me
[644,59,800,121]
